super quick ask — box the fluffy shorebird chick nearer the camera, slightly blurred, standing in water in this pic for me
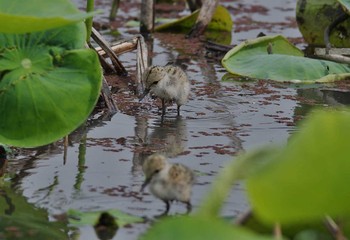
[141,153,194,215]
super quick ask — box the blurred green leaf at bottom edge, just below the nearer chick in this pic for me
[141,216,273,240]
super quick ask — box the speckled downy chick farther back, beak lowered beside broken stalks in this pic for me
[140,65,190,115]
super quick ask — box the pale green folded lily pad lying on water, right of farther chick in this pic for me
[222,35,350,83]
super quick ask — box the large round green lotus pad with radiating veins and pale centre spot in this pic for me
[0,27,102,147]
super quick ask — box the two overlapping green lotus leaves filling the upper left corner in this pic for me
[0,0,102,147]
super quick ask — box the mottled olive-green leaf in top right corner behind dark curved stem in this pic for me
[296,0,350,47]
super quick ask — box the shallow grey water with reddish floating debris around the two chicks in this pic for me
[2,0,349,240]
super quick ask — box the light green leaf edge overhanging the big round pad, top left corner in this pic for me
[0,0,95,33]
